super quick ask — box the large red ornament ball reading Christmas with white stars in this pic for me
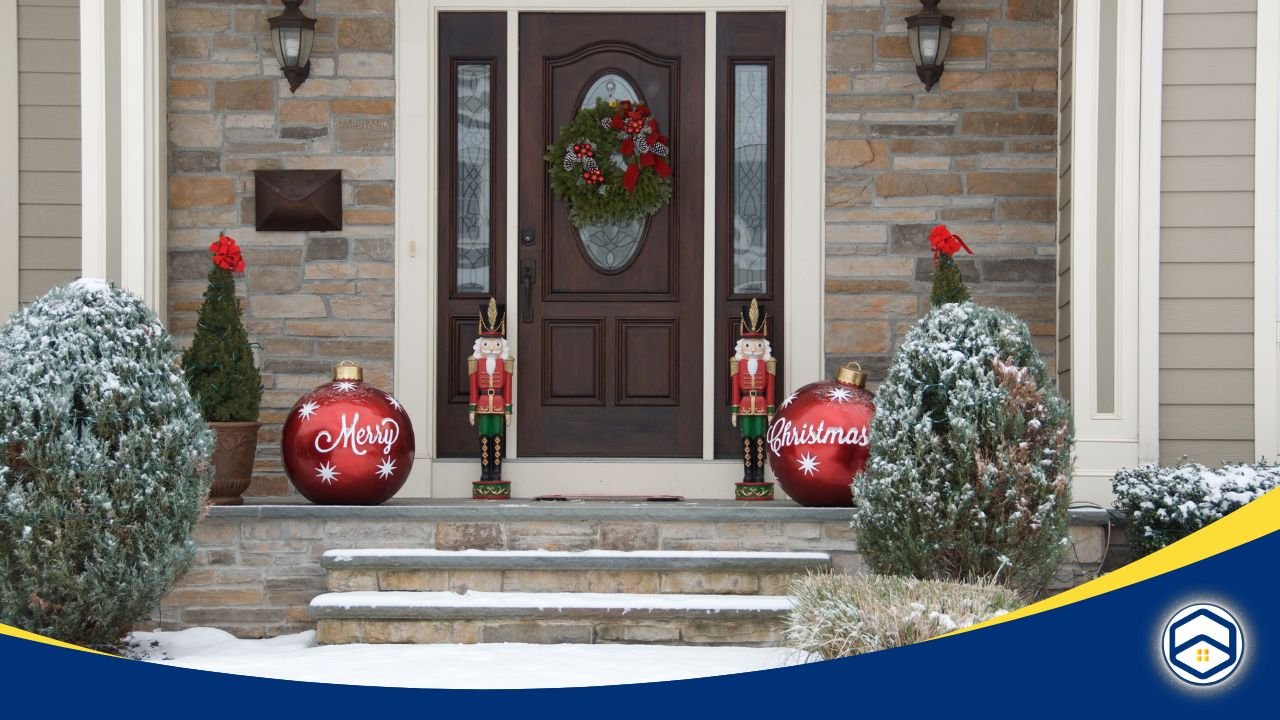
[768,366,876,507]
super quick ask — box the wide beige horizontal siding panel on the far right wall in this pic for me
[1160,0,1257,464]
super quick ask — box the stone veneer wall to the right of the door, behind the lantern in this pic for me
[826,0,1057,380]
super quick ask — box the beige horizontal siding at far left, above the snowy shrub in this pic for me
[18,0,81,304]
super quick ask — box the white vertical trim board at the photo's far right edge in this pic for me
[1253,1,1280,461]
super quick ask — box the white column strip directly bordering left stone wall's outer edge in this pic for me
[119,0,168,319]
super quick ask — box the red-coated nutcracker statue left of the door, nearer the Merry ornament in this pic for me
[467,297,516,500]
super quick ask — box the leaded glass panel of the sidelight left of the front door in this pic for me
[454,64,493,295]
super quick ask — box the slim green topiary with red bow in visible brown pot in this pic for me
[182,233,262,505]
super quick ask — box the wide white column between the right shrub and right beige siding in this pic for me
[1070,0,1158,503]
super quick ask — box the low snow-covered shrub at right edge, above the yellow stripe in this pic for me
[1111,461,1280,556]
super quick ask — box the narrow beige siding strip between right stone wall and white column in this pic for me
[1057,0,1075,401]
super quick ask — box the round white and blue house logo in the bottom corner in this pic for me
[1160,603,1244,685]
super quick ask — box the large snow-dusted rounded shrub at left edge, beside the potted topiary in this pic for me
[0,281,212,647]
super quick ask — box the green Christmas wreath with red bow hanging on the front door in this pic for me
[545,100,671,227]
